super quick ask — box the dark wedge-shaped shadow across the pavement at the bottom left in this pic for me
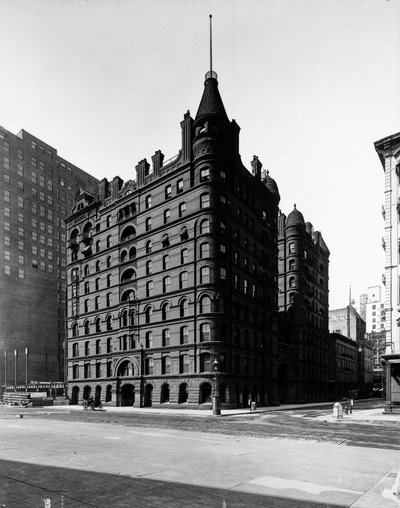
[0,457,338,508]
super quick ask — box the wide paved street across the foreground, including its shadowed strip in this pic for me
[0,404,400,508]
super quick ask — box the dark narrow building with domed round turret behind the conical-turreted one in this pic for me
[278,207,330,403]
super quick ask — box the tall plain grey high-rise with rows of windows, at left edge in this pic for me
[0,127,97,386]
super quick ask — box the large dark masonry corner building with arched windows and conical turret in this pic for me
[67,72,280,407]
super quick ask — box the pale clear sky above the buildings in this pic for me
[0,0,400,309]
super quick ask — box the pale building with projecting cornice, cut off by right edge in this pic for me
[375,132,400,404]
